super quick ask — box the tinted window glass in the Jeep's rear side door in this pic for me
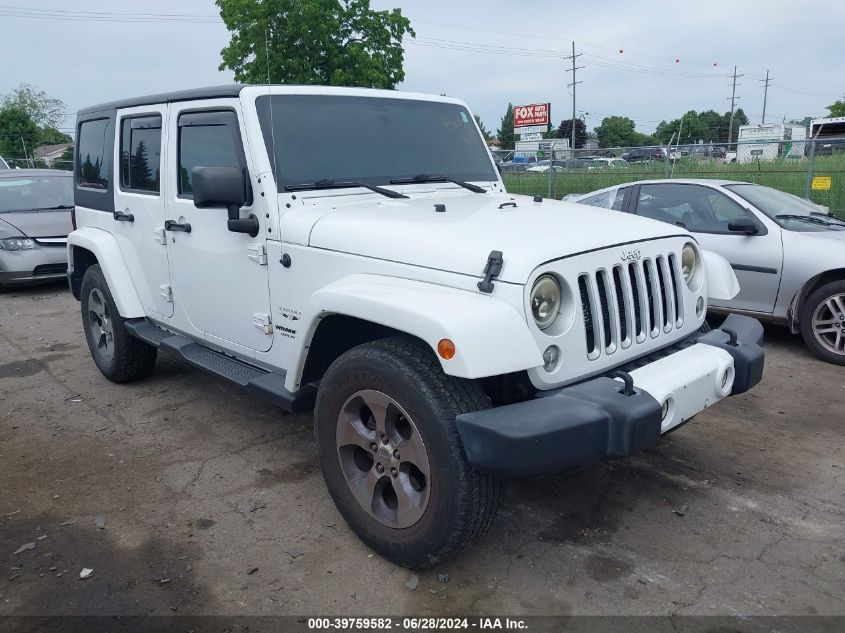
[120,115,161,193]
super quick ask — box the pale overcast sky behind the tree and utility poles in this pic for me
[0,0,845,138]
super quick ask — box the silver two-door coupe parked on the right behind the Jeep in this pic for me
[569,179,845,365]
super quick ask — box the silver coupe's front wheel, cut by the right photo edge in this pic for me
[799,281,845,365]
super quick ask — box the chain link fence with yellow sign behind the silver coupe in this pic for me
[498,137,845,219]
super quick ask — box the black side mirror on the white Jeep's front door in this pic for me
[191,167,260,237]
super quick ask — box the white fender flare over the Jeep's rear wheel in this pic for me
[67,227,146,319]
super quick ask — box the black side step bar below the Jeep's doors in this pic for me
[125,319,317,413]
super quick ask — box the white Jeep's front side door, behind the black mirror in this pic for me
[166,99,273,356]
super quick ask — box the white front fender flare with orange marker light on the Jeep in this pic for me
[294,274,543,381]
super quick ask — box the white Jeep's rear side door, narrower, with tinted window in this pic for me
[110,105,173,319]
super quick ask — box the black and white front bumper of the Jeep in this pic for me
[456,314,763,477]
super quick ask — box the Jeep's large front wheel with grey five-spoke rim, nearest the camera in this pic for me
[315,338,502,569]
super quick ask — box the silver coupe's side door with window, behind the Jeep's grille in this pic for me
[634,183,783,314]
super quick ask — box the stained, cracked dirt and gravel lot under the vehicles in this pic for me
[0,284,845,615]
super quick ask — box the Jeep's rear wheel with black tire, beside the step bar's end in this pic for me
[80,264,158,383]
